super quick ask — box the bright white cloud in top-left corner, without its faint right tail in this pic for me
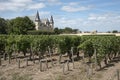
[0,0,45,11]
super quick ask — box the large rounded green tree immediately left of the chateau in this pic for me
[8,16,35,34]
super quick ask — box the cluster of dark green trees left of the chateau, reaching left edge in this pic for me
[0,16,35,34]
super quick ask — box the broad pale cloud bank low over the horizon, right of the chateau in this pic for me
[55,13,120,31]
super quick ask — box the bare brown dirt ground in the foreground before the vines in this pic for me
[0,56,120,80]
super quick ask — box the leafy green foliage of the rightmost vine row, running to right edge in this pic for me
[78,36,120,64]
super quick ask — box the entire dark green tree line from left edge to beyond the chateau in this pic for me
[0,16,78,35]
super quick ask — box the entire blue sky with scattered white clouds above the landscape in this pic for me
[0,0,120,32]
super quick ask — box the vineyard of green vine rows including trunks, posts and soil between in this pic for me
[0,35,120,80]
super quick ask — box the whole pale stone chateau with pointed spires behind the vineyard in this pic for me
[35,11,54,31]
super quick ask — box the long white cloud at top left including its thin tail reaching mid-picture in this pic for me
[0,0,61,12]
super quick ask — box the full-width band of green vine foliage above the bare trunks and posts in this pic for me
[0,35,120,66]
